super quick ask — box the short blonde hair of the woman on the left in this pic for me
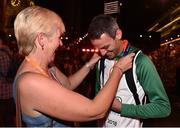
[14,6,65,56]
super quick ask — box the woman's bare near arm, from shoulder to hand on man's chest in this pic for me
[19,54,134,121]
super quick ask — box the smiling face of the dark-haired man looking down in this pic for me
[91,33,120,60]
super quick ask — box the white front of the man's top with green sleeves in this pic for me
[98,50,145,127]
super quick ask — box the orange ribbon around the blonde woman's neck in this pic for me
[25,56,49,77]
